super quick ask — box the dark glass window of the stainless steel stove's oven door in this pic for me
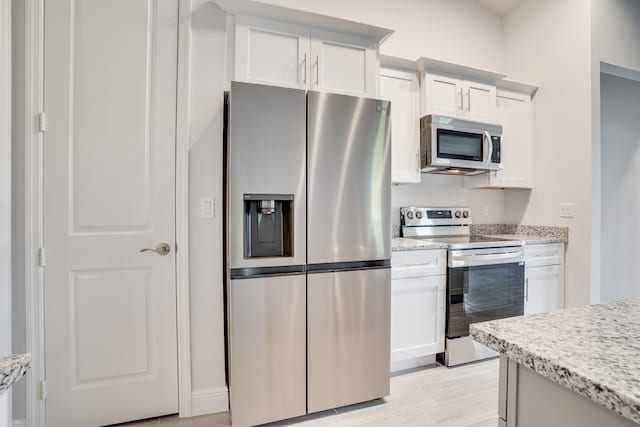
[447,263,524,338]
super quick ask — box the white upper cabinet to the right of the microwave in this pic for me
[465,90,533,188]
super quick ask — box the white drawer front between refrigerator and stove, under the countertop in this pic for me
[391,249,447,279]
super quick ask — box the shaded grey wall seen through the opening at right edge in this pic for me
[600,73,640,302]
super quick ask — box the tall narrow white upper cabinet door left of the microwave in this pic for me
[380,69,420,184]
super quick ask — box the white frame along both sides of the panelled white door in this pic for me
[21,0,192,427]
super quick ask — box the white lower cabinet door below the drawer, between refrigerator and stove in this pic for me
[391,275,446,362]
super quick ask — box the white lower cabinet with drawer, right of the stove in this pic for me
[524,243,564,314]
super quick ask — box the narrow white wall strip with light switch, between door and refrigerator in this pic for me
[189,0,227,411]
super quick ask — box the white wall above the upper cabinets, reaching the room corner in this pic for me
[254,0,504,71]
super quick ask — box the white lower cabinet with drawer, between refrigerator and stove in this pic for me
[391,250,447,370]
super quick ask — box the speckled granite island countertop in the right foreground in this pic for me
[470,299,640,423]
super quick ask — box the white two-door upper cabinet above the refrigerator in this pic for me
[232,15,379,97]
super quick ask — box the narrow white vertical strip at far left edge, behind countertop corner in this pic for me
[0,0,12,427]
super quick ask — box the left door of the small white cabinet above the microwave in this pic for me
[424,73,463,118]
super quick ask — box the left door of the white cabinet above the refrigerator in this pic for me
[238,15,310,88]
